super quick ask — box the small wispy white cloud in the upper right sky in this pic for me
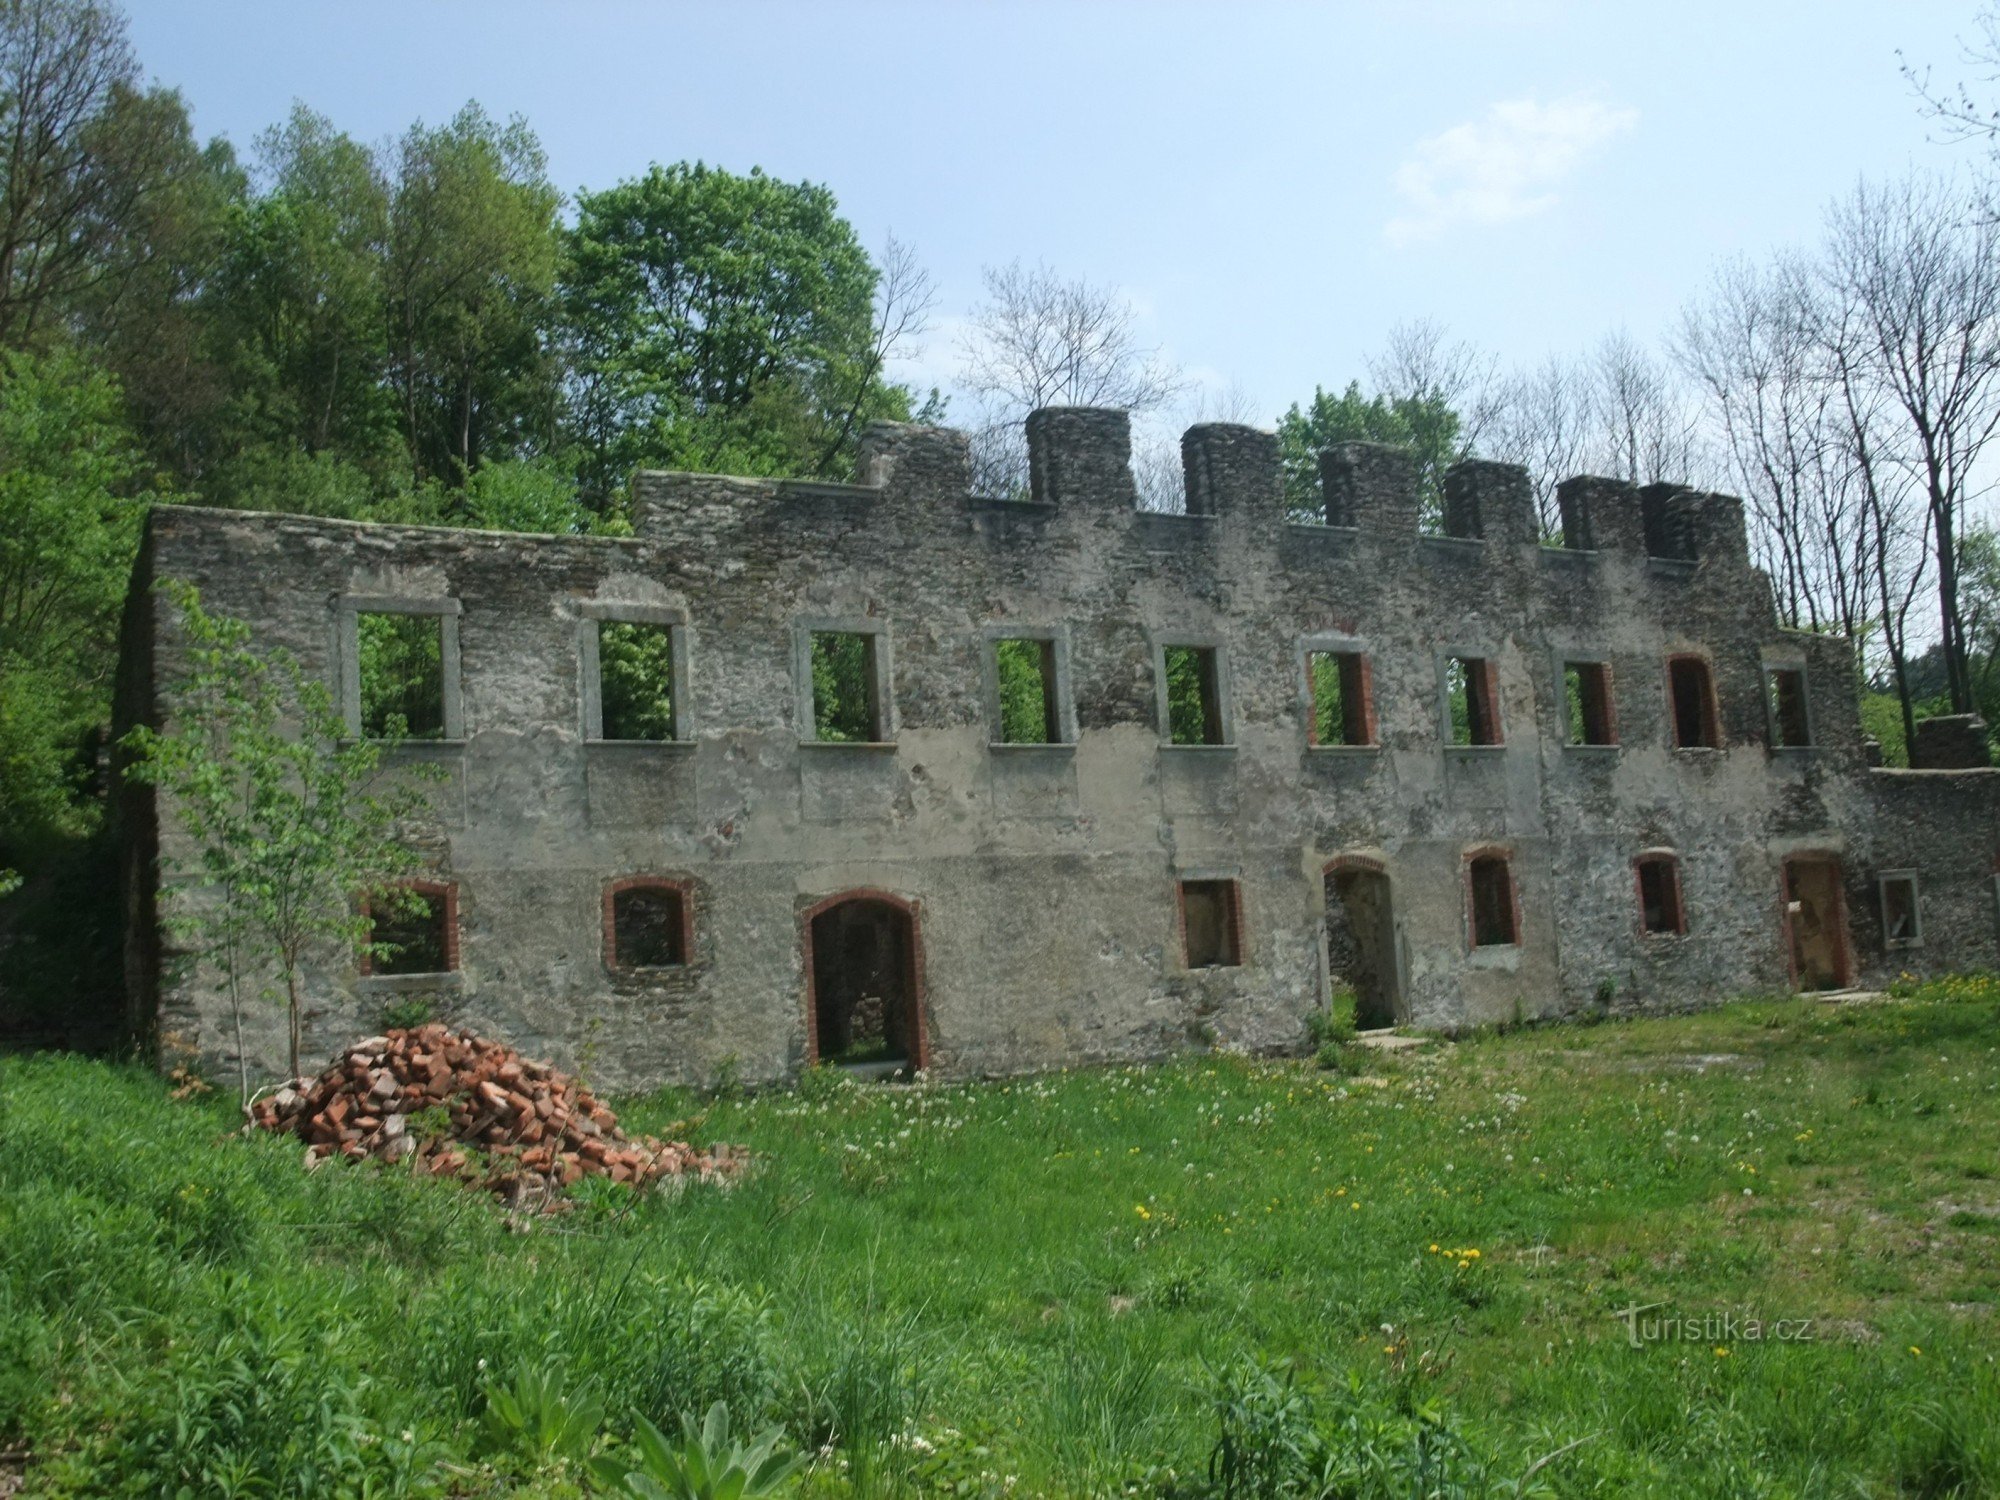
[1384,94,1638,244]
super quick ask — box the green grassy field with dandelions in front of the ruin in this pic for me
[0,978,2000,1496]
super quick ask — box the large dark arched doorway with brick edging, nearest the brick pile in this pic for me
[804,890,930,1070]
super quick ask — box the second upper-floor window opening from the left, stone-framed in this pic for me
[576,600,694,744]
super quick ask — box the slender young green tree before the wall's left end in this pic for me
[122,582,442,1104]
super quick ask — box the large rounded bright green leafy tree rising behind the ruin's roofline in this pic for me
[562,162,910,506]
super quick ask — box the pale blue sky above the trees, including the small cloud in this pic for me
[130,0,1976,420]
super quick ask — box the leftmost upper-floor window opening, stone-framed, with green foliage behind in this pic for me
[334,594,466,744]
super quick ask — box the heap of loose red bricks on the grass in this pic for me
[252,1024,744,1198]
